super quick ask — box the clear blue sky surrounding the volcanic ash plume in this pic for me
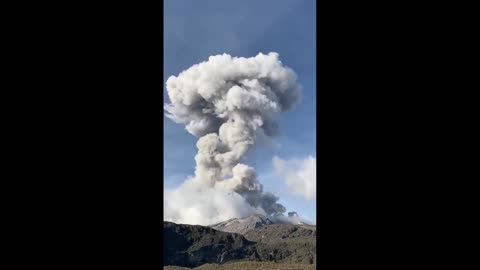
[163,0,316,219]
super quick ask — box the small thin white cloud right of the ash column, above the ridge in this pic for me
[273,156,317,200]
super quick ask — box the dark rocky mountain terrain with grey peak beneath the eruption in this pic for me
[163,215,316,267]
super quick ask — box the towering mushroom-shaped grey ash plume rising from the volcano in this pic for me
[165,53,301,224]
